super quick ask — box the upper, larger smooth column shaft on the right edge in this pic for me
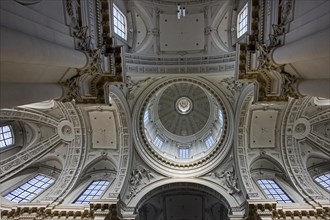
[271,28,330,64]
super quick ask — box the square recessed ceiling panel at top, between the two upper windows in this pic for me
[159,13,204,51]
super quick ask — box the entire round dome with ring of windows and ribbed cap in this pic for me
[134,79,232,175]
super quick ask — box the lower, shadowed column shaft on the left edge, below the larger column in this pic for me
[0,83,63,108]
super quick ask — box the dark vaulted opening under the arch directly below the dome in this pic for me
[135,182,231,219]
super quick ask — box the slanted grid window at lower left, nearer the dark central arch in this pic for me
[74,180,109,204]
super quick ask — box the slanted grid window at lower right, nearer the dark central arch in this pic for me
[258,179,292,203]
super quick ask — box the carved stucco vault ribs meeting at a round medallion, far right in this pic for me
[281,97,330,203]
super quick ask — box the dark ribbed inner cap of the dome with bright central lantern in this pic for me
[158,83,210,136]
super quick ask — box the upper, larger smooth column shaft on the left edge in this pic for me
[0,26,88,68]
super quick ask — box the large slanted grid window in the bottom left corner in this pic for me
[5,175,54,202]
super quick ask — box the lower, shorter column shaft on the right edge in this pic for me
[297,79,330,99]
